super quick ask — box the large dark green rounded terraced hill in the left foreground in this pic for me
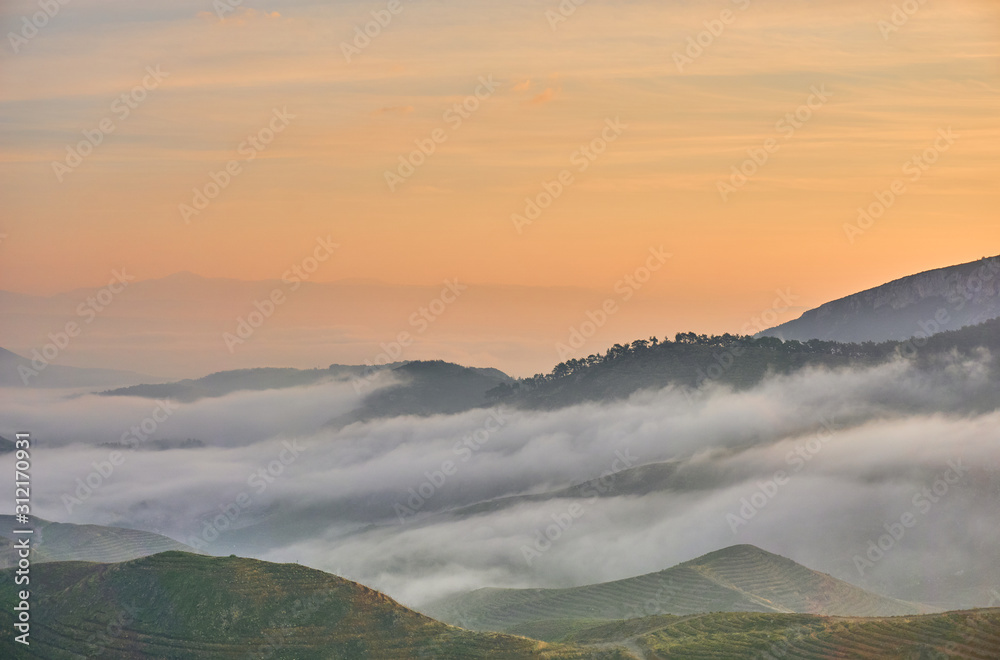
[0,552,631,660]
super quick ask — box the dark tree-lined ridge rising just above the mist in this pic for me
[84,318,1000,427]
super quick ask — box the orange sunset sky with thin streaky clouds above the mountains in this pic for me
[0,0,1000,374]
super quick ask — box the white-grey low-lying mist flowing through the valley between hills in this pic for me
[0,354,1000,607]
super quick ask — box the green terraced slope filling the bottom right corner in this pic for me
[564,609,1000,660]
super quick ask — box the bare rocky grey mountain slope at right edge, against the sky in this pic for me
[760,257,1000,342]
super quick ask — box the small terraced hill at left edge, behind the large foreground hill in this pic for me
[0,515,197,568]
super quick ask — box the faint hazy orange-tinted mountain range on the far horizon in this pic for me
[0,272,648,378]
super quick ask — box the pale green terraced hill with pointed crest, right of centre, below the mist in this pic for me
[422,545,932,631]
